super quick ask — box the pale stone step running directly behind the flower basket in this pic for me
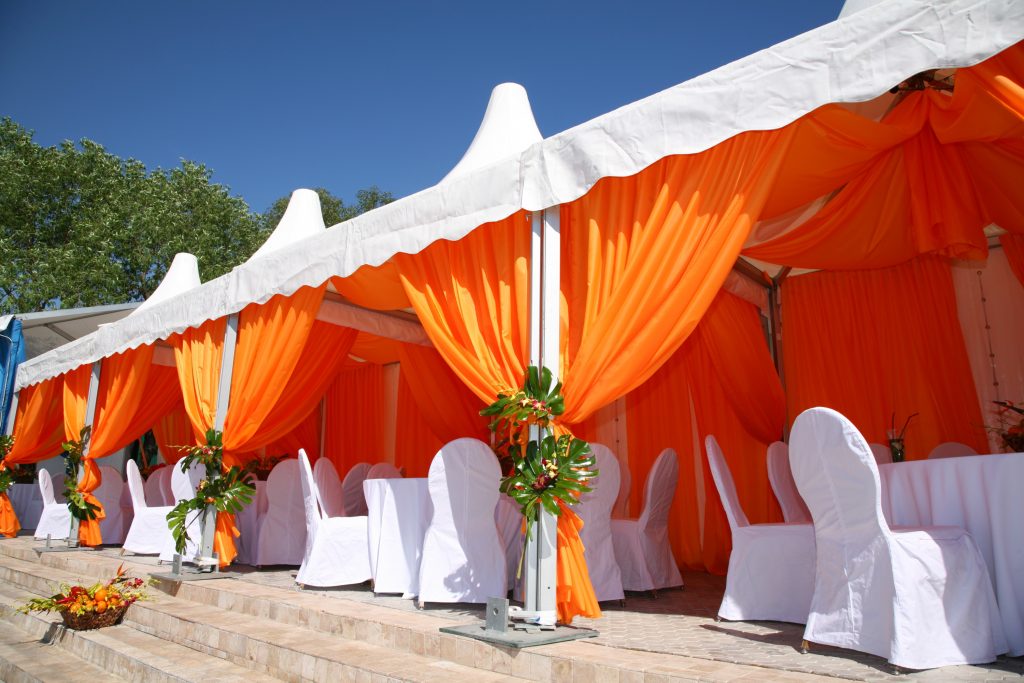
[0,553,521,682]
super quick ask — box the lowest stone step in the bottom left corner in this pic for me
[0,622,124,683]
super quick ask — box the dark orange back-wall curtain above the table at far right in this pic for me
[782,257,986,459]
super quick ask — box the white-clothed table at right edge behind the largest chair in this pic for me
[879,453,1024,656]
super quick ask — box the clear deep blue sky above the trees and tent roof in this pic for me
[0,0,842,211]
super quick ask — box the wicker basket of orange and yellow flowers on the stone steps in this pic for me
[17,564,146,631]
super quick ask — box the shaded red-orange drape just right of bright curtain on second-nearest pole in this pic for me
[241,321,358,459]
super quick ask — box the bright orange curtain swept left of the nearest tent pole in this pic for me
[394,212,531,403]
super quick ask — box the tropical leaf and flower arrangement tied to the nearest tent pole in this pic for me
[480,366,597,538]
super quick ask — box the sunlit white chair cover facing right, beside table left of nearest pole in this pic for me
[290,449,370,587]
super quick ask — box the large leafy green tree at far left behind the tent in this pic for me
[0,118,263,313]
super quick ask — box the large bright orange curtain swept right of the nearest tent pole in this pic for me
[561,130,792,422]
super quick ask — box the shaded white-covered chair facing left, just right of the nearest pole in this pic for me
[611,449,683,591]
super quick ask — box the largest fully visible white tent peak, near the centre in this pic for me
[441,83,544,182]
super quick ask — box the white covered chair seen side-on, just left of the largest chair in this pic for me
[705,436,814,624]
